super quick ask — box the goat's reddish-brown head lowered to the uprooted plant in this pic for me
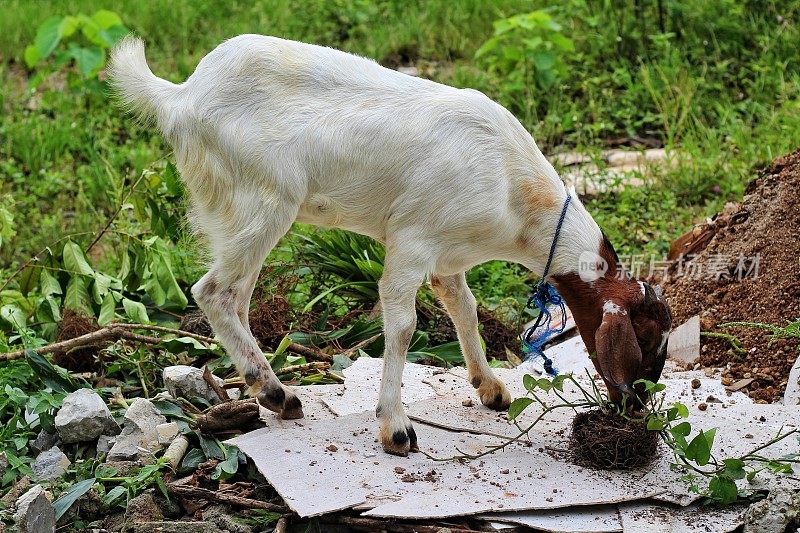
[553,235,672,403]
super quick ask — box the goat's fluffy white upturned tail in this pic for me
[108,35,178,131]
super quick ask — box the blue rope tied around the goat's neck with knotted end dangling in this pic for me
[522,192,572,376]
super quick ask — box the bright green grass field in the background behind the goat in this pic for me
[0,0,800,301]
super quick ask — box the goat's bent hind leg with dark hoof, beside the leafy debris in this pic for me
[192,206,303,419]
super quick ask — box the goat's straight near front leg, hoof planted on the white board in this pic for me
[375,261,424,456]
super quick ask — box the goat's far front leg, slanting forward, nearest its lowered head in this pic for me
[431,273,511,411]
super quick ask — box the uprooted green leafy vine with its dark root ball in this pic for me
[426,374,800,504]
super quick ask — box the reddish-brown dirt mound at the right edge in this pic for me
[665,150,800,402]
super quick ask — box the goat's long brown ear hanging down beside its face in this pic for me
[594,310,642,387]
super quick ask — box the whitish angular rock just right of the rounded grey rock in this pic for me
[108,398,167,461]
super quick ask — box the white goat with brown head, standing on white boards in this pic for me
[104,35,670,455]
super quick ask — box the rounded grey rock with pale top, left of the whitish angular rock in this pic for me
[55,389,120,443]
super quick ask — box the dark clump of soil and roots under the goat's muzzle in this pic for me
[569,409,658,470]
